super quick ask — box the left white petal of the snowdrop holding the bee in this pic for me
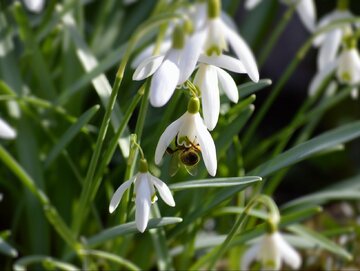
[155,116,183,165]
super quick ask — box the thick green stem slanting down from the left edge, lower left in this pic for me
[0,145,81,255]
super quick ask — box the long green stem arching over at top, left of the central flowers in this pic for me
[73,14,183,235]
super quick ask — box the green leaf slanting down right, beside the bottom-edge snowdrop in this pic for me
[288,225,353,261]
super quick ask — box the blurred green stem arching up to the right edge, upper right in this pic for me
[243,18,360,148]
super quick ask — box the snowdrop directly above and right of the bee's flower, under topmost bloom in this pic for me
[194,55,246,131]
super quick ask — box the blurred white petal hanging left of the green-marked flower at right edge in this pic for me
[318,29,342,70]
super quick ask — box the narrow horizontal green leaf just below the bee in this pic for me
[169,176,261,190]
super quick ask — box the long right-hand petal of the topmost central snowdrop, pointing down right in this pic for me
[222,23,259,83]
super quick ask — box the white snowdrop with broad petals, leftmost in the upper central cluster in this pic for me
[133,28,202,107]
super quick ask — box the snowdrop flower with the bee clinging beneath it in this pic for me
[155,97,217,176]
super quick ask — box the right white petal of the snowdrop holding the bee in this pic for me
[195,113,217,176]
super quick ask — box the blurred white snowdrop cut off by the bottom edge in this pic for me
[241,231,301,270]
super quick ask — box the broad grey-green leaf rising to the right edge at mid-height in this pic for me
[248,121,360,177]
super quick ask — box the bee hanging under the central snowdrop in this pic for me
[166,137,201,176]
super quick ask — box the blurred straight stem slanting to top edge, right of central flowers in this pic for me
[258,3,296,67]
